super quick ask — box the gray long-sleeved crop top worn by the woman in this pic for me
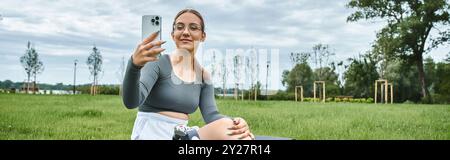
[122,54,225,123]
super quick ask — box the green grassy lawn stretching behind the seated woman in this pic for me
[0,94,450,140]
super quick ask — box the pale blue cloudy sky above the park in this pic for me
[0,0,450,89]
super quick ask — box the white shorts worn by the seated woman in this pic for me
[131,112,188,140]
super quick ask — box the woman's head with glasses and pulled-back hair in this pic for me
[172,12,206,53]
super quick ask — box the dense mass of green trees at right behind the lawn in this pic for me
[283,0,450,103]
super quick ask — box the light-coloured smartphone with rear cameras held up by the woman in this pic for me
[141,15,162,41]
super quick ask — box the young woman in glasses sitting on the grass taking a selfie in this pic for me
[123,9,254,140]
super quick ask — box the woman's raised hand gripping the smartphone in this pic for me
[132,31,166,67]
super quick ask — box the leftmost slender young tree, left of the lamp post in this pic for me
[20,41,44,93]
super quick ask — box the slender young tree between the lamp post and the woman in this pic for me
[86,45,103,95]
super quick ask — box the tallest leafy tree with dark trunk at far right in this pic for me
[347,0,450,102]
